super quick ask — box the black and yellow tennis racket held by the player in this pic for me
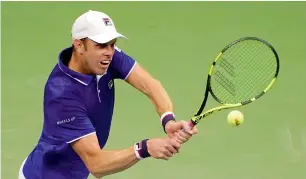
[190,37,279,128]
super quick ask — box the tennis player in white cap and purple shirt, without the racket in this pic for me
[19,11,197,179]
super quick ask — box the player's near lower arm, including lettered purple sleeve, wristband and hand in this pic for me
[45,86,180,178]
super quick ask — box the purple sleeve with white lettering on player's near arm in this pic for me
[45,95,95,143]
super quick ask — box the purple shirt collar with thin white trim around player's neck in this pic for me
[58,47,95,86]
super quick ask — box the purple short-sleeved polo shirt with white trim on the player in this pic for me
[23,47,136,179]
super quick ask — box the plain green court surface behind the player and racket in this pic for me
[1,2,306,179]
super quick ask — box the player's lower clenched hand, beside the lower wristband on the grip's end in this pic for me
[147,138,181,160]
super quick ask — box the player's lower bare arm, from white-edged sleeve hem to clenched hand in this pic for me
[71,134,180,178]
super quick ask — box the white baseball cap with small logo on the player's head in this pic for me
[71,10,126,43]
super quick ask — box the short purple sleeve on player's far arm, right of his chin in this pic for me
[110,47,136,80]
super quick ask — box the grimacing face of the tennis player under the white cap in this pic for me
[79,39,117,75]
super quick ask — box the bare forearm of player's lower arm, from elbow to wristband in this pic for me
[91,147,139,178]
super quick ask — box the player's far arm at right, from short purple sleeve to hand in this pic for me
[110,47,197,142]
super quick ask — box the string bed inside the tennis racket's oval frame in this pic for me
[211,41,277,104]
